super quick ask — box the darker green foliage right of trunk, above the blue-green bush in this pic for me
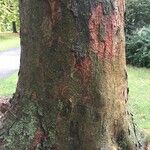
[126,0,150,34]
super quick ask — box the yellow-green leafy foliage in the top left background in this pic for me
[0,0,19,32]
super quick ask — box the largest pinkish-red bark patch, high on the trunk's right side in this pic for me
[88,4,120,59]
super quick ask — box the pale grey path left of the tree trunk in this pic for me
[0,48,20,79]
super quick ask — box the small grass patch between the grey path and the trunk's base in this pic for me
[0,73,17,96]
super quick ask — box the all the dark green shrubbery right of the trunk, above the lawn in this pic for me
[126,0,150,67]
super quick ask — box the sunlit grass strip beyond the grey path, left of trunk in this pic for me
[0,33,20,51]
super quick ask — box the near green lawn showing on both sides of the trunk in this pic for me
[0,66,150,129]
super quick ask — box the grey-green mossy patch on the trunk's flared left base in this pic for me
[3,99,38,150]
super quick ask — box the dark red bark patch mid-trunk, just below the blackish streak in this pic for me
[75,57,92,84]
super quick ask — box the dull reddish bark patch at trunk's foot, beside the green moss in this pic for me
[30,127,46,150]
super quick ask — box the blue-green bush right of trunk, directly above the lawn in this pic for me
[126,26,150,67]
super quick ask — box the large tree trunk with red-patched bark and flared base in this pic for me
[0,0,143,150]
